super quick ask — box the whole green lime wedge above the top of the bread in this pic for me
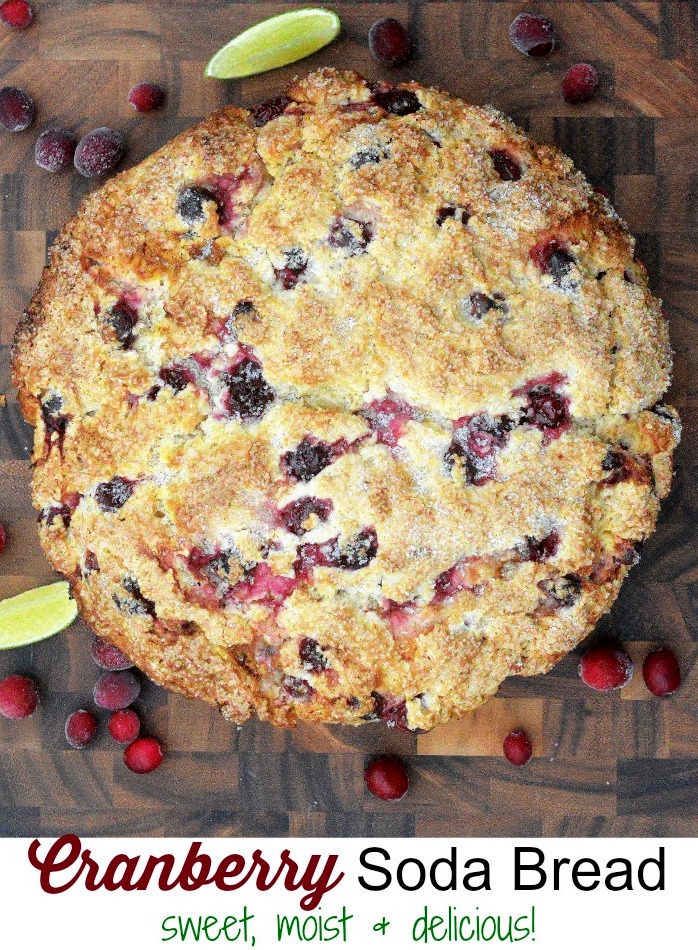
[205,9,340,79]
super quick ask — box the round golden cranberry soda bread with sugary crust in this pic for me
[14,69,679,729]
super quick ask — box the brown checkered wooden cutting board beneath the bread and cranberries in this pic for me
[0,0,698,836]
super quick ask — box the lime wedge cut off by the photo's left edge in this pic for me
[0,581,78,650]
